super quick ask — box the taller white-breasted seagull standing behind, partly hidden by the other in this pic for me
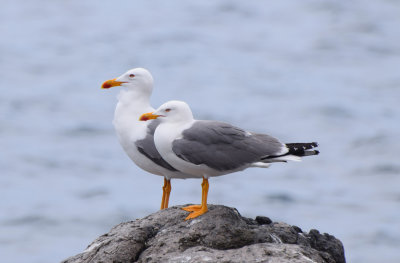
[101,68,190,209]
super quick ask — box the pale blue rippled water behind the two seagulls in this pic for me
[0,0,400,263]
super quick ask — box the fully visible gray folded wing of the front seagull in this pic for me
[172,121,285,171]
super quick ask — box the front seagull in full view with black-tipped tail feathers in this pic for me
[140,101,319,220]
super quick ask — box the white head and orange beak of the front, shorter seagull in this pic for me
[139,100,193,122]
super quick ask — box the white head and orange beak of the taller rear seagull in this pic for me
[101,68,153,93]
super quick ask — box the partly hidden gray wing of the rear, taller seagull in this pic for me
[135,120,177,171]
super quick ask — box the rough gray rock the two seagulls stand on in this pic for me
[63,205,346,263]
